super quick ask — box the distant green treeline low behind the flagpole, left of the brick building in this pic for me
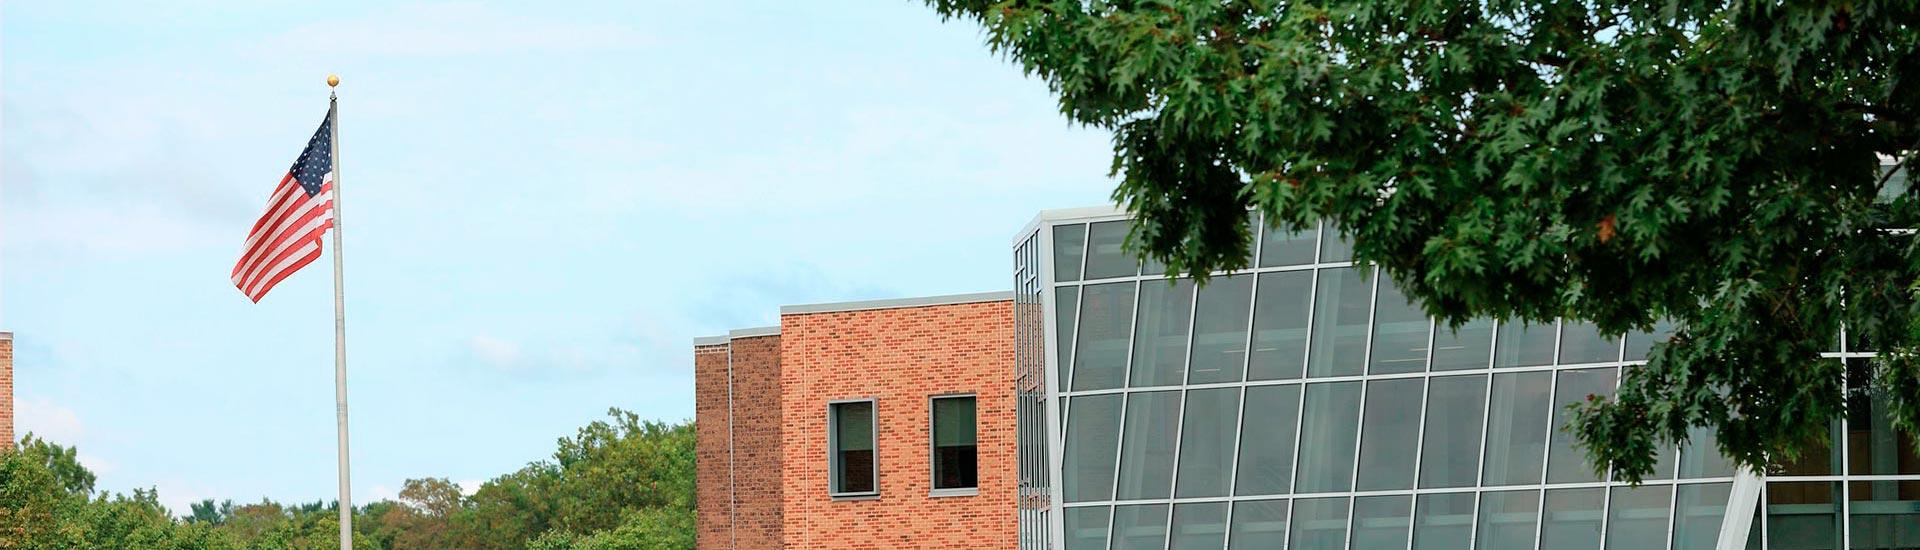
[0,410,693,550]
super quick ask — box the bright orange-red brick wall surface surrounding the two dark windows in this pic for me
[779,300,1018,548]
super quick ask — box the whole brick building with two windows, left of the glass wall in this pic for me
[693,292,1018,548]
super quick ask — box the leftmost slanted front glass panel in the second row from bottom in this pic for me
[1060,394,1121,502]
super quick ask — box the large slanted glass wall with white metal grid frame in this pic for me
[1016,210,1920,550]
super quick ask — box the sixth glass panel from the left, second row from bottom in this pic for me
[1351,379,1425,490]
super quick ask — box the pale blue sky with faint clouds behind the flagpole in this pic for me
[0,0,1114,513]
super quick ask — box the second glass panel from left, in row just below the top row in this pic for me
[1127,279,1194,388]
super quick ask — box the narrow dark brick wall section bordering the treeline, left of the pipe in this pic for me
[693,344,733,548]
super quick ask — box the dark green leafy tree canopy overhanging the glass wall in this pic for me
[929,0,1920,479]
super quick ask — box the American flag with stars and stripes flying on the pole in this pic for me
[232,108,334,302]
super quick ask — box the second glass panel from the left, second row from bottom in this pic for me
[1114,392,1181,500]
